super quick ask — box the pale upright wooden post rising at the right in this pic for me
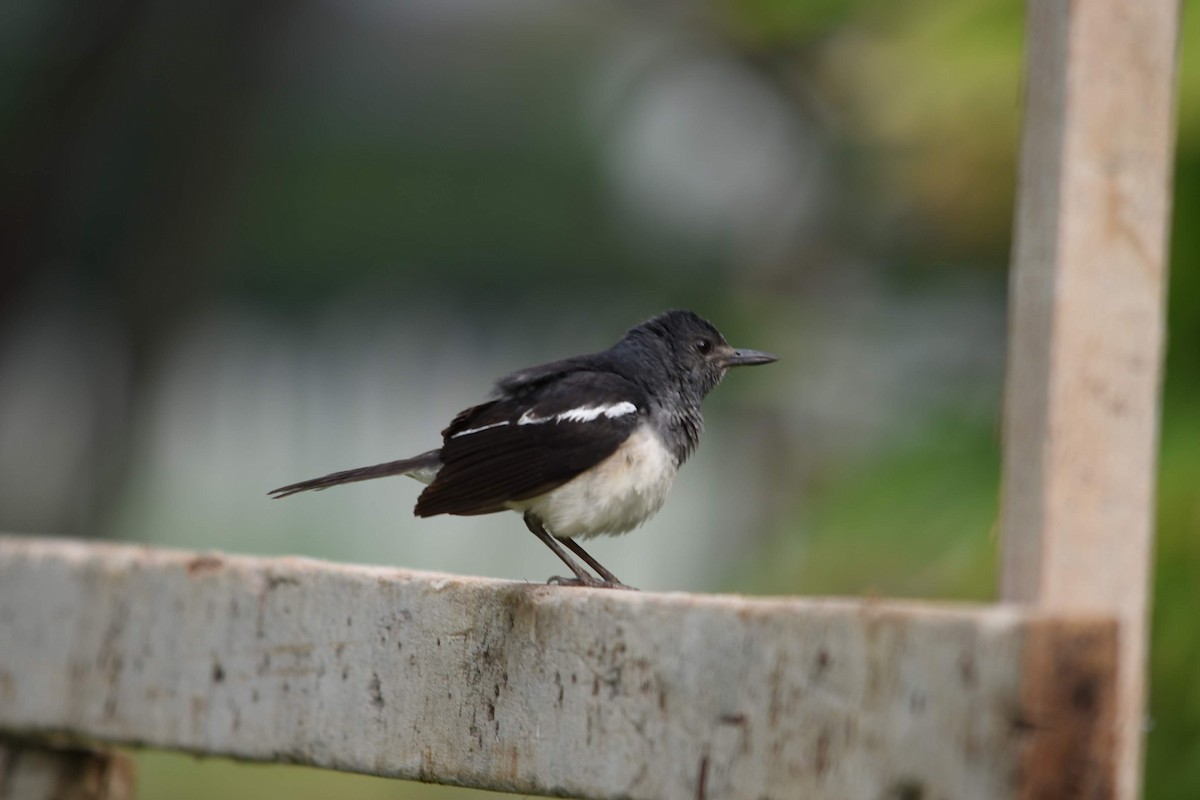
[1001,0,1180,798]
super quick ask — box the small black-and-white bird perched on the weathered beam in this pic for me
[269,309,776,589]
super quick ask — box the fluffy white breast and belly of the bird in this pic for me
[510,426,677,539]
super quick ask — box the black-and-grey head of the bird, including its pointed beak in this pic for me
[622,311,775,403]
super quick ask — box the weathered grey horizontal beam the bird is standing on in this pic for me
[0,537,1116,800]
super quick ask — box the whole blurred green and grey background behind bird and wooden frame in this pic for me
[0,0,1200,800]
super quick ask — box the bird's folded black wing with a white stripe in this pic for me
[415,372,647,517]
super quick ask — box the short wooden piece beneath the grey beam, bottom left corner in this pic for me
[0,740,133,800]
